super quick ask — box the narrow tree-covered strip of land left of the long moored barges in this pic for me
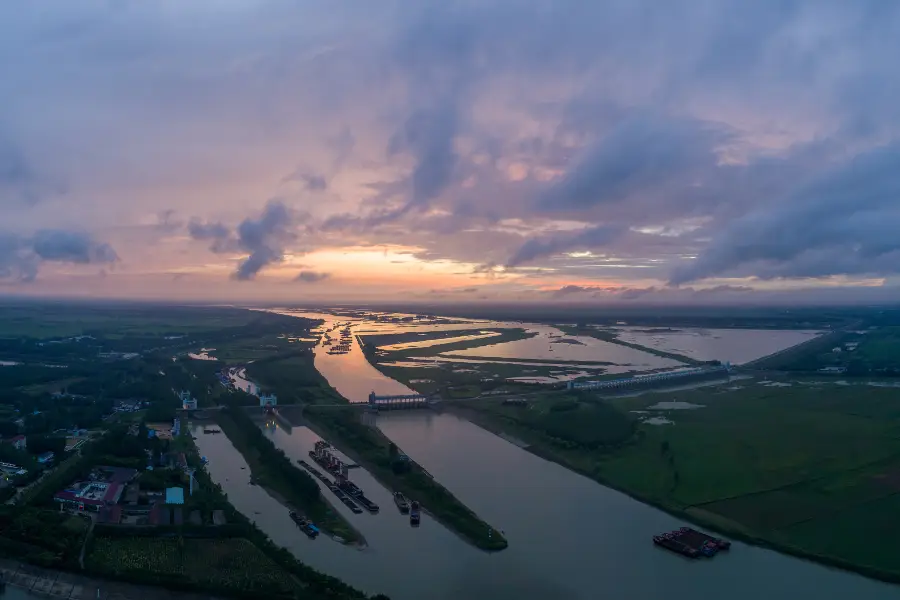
[215,408,366,547]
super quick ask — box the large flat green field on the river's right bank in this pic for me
[451,381,900,581]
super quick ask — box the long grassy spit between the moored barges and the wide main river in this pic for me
[306,407,507,550]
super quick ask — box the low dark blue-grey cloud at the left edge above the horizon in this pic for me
[0,229,119,281]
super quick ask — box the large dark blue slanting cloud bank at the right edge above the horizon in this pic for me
[671,142,900,284]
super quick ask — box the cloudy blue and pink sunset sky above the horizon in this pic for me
[0,0,900,304]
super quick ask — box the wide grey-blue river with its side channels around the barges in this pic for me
[195,314,900,600]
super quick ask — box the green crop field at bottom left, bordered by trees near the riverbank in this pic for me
[86,536,298,593]
